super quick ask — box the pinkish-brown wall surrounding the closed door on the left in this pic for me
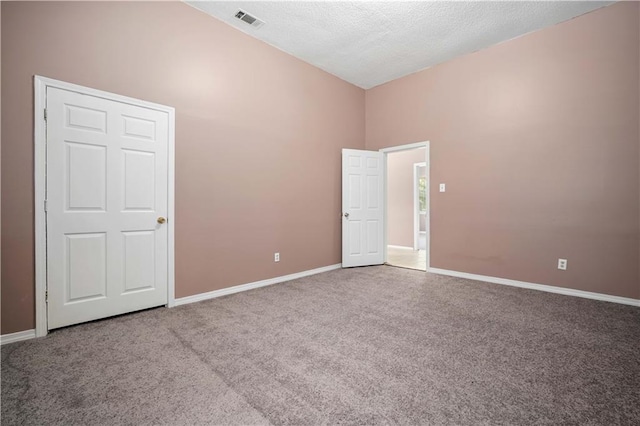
[1,2,365,334]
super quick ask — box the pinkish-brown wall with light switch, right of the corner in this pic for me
[366,2,640,298]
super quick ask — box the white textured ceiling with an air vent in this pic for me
[186,1,613,89]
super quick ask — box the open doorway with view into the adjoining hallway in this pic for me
[381,142,429,271]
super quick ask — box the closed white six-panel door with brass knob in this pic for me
[46,87,171,329]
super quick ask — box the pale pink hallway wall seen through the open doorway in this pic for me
[387,148,425,247]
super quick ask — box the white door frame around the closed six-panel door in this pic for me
[33,75,175,337]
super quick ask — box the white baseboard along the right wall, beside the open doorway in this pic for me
[427,268,640,307]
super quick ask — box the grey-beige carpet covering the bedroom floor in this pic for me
[1,266,640,425]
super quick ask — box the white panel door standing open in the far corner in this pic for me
[342,149,384,267]
